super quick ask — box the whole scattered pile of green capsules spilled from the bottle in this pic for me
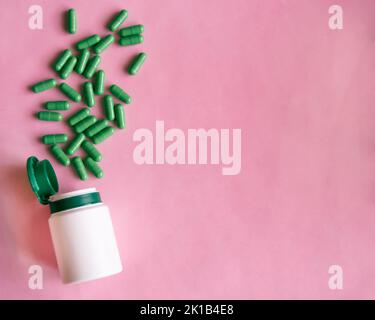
[31,9,146,180]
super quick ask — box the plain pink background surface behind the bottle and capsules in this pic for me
[0,0,375,299]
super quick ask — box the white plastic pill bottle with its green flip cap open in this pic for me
[27,157,122,283]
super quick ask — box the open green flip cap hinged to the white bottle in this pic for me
[26,157,59,204]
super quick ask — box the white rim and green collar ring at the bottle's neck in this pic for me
[49,188,102,214]
